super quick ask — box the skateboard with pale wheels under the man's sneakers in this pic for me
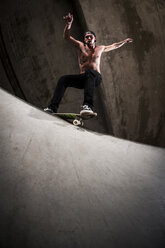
[53,112,97,126]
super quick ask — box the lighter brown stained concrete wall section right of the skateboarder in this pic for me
[80,0,165,146]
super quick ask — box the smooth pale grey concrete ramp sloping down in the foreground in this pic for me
[0,90,165,248]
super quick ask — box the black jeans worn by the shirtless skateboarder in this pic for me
[49,69,102,112]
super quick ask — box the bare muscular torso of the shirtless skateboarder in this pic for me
[78,44,104,73]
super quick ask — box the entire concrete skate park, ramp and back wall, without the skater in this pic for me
[0,1,165,248]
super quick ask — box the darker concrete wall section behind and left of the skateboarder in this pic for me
[0,0,106,132]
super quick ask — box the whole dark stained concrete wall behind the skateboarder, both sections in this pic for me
[0,0,165,146]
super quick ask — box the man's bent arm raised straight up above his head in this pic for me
[63,13,82,48]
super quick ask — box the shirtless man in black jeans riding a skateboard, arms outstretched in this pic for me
[44,13,133,114]
